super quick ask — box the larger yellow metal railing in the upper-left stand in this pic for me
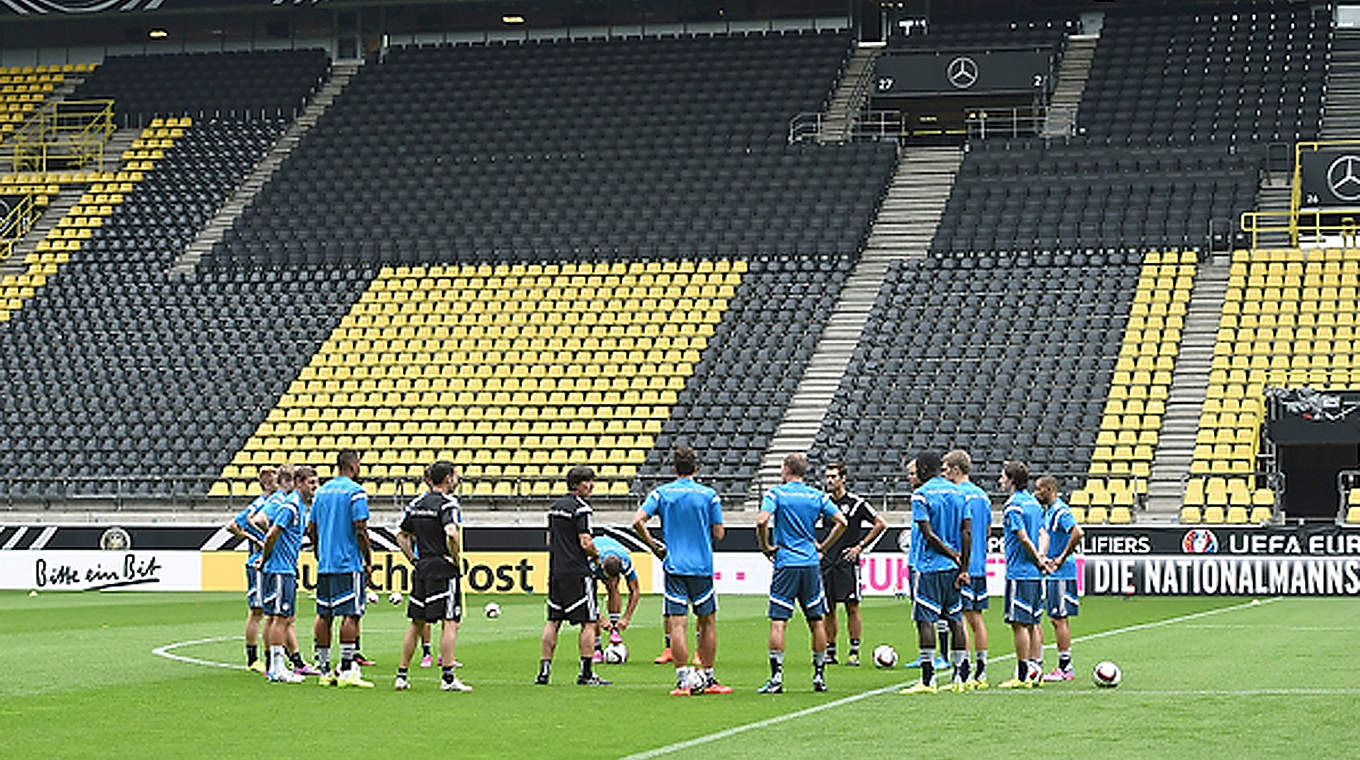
[0,101,116,171]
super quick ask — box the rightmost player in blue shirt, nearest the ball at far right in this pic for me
[1034,474,1083,683]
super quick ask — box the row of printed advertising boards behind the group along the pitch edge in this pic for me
[0,525,1360,595]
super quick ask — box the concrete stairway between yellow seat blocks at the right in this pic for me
[1148,257,1231,517]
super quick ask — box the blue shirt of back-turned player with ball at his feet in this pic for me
[644,477,722,578]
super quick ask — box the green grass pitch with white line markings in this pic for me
[0,593,1360,760]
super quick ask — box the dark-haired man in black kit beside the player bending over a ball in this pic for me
[533,465,609,687]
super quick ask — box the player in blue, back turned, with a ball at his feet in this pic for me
[630,446,732,696]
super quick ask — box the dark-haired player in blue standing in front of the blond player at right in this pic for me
[900,451,972,693]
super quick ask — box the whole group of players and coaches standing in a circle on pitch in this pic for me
[228,446,1081,696]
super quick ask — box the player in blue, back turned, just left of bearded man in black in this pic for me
[756,454,846,693]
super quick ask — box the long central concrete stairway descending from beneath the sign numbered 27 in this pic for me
[758,147,963,488]
